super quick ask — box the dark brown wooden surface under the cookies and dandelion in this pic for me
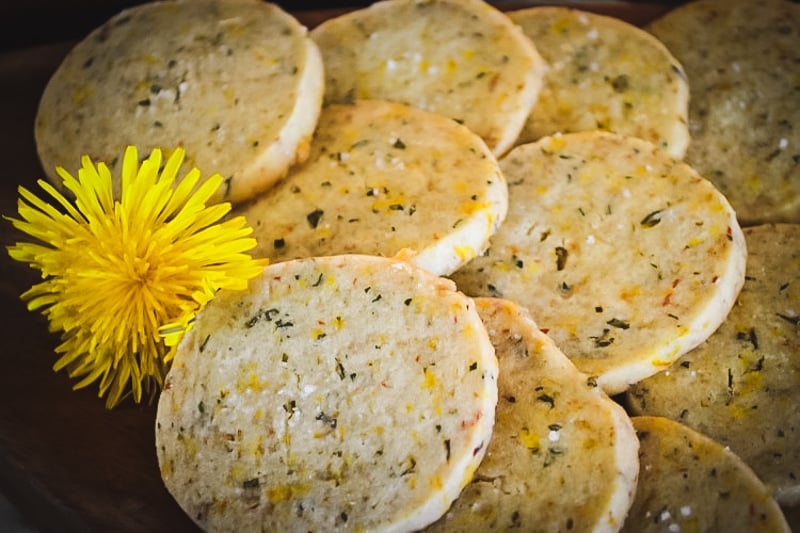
[0,2,800,532]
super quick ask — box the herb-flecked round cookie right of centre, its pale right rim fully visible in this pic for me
[453,131,746,394]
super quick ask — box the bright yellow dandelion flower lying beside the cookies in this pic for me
[5,147,265,409]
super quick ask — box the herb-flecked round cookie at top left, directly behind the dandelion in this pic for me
[35,0,324,202]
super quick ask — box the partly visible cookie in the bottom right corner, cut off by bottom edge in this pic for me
[622,417,791,533]
